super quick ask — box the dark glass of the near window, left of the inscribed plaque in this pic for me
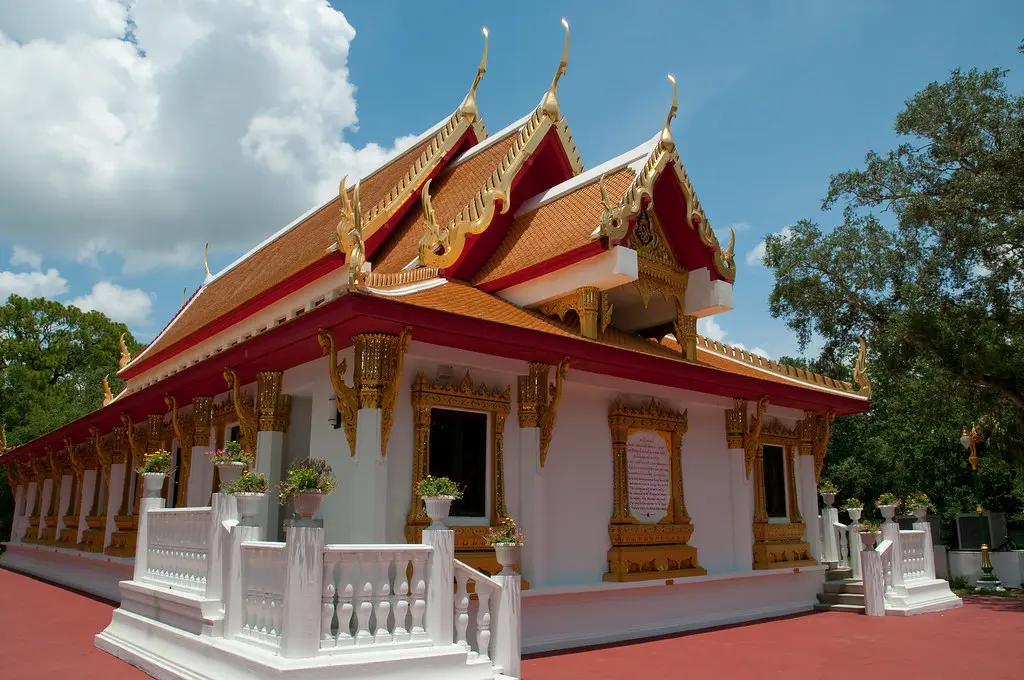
[428,409,487,517]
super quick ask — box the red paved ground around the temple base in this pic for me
[0,569,1024,680]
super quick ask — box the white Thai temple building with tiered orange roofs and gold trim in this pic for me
[0,23,870,659]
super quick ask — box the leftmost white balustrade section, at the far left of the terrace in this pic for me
[142,508,212,596]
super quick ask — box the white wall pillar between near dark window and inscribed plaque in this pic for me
[520,427,547,585]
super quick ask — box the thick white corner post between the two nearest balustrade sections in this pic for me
[281,525,324,658]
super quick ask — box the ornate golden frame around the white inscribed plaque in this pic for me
[603,399,708,582]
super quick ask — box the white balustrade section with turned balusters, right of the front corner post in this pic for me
[319,545,432,653]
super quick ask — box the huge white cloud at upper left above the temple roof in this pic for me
[0,0,415,271]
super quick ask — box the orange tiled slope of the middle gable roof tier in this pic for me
[373,130,518,273]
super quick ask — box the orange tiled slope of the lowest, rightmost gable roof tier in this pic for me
[473,167,635,286]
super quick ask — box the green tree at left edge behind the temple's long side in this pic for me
[0,295,139,536]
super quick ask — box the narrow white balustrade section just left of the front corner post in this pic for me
[238,541,287,650]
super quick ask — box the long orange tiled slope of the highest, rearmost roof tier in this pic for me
[128,136,440,368]
